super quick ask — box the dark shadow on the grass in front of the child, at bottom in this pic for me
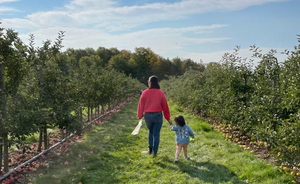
[161,158,246,184]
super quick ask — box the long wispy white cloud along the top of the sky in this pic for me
[2,0,286,31]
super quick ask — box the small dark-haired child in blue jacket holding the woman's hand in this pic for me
[171,115,194,162]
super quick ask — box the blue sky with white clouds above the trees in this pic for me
[0,0,300,63]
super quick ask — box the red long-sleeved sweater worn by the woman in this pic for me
[137,89,170,121]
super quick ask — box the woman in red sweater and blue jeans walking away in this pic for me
[137,75,172,157]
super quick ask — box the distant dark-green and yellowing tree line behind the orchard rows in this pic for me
[65,47,204,84]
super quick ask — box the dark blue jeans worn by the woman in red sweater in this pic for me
[145,112,163,155]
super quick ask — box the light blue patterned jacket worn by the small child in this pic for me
[171,124,194,144]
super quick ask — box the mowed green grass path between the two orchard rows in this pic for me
[32,99,292,184]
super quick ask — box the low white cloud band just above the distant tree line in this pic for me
[20,25,229,54]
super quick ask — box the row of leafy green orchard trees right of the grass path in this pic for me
[162,35,300,165]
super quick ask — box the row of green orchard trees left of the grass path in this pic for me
[0,29,145,173]
